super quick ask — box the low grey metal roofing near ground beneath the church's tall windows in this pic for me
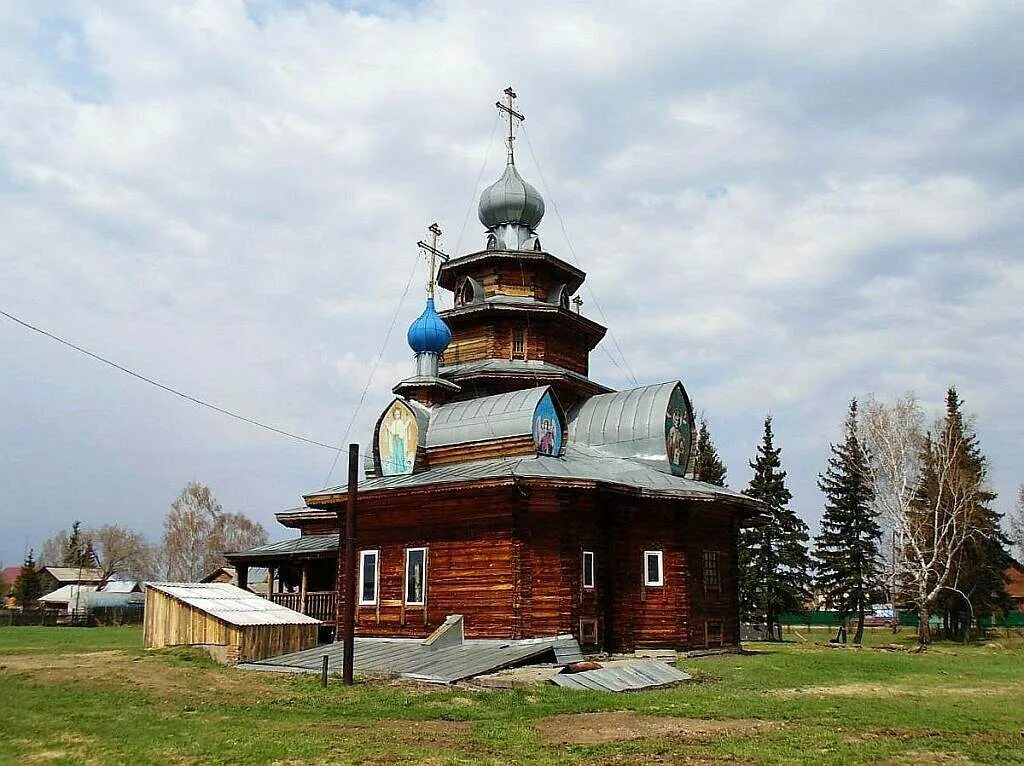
[235,636,582,684]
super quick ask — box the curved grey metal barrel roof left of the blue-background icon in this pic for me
[427,386,551,448]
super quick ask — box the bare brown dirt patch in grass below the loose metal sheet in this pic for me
[537,711,778,746]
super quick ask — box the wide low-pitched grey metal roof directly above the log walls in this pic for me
[306,442,761,508]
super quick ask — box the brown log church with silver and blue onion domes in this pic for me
[228,90,760,651]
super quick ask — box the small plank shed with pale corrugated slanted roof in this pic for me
[142,583,321,665]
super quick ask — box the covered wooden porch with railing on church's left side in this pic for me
[224,535,338,627]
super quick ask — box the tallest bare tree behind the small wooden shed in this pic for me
[164,481,267,583]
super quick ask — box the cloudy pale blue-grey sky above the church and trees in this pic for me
[0,0,1024,563]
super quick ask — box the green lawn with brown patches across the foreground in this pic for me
[0,628,1024,766]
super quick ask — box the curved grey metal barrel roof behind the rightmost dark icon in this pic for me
[568,381,680,462]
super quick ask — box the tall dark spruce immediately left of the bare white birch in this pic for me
[814,399,882,644]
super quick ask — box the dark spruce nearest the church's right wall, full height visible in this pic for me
[739,415,811,640]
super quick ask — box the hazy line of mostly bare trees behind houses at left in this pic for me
[0,481,267,606]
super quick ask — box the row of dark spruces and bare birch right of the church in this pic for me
[694,388,1024,643]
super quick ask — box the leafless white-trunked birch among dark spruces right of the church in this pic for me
[862,394,978,642]
